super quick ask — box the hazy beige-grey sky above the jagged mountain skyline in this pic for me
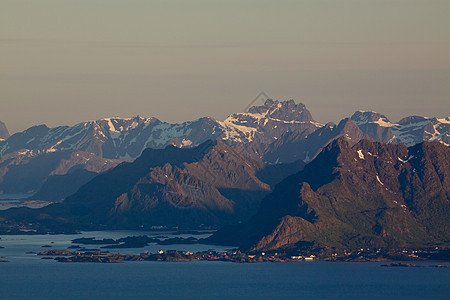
[0,0,450,133]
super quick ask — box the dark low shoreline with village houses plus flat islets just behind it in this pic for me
[0,229,450,263]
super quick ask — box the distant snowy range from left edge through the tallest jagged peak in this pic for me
[0,100,321,197]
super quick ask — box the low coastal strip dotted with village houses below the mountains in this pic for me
[32,248,449,263]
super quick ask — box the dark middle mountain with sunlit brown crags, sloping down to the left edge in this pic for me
[0,141,303,229]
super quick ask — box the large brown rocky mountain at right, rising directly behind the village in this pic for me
[211,137,450,251]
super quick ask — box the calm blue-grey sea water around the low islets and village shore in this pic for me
[0,232,450,299]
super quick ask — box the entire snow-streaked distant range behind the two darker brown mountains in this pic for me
[0,99,450,193]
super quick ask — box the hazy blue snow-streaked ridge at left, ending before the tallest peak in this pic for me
[0,117,219,193]
